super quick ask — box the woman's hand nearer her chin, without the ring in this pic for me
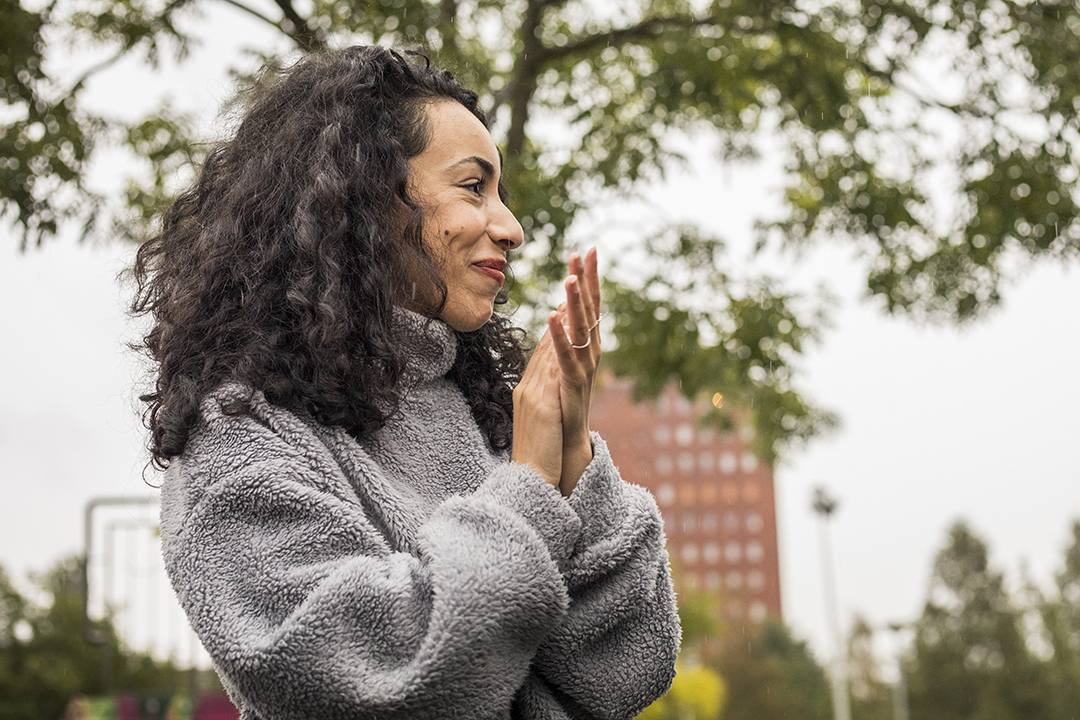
[510,312,566,487]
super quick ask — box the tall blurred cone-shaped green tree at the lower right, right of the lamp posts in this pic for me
[907,522,1051,720]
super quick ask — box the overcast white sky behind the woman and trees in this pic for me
[0,4,1080,669]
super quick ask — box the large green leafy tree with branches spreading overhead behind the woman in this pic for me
[0,0,1080,460]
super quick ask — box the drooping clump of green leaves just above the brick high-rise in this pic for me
[605,227,837,462]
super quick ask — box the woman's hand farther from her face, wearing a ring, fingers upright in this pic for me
[550,247,600,495]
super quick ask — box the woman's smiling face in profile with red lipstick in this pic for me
[409,100,524,332]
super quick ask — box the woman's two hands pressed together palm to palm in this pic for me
[511,248,600,495]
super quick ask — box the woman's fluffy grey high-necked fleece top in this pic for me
[161,313,679,720]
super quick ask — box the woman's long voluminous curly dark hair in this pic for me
[132,46,525,468]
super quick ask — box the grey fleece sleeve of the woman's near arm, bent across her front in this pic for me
[162,397,581,720]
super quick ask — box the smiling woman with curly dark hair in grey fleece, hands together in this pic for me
[134,47,678,720]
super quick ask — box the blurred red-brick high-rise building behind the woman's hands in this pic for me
[590,377,781,623]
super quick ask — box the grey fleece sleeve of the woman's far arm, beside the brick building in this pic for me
[517,433,680,718]
